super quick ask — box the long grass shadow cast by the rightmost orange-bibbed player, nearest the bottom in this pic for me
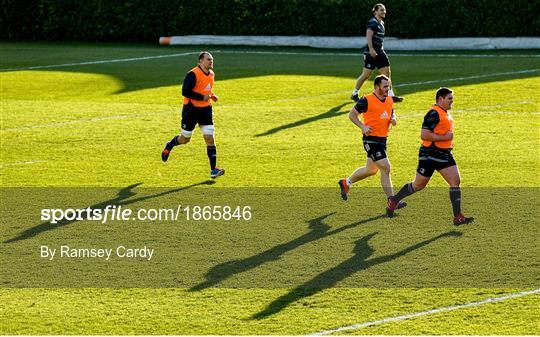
[251,231,462,319]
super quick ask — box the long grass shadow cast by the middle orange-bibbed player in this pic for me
[190,212,385,291]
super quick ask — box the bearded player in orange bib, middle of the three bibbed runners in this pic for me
[338,75,406,208]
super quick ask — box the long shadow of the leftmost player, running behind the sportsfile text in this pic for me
[4,180,215,243]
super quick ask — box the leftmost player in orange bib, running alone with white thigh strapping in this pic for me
[161,52,225,179]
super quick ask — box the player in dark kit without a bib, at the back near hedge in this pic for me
[351,3,403,102]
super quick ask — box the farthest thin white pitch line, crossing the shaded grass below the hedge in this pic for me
[0,50,540,72]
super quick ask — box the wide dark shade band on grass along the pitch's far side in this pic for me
[6,43,538,97]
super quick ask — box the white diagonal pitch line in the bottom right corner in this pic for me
[308,288,540,336]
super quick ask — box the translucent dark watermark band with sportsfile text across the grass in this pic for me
[0,184,540,286]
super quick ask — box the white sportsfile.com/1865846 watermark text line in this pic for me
[40,205,252,224]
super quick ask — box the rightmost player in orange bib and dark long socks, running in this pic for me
[386,88,474,226]
